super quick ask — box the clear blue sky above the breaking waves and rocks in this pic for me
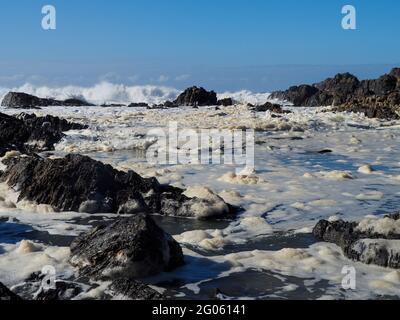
[0,0,400,91]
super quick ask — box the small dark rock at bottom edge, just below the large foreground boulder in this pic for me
[109,278,164,301]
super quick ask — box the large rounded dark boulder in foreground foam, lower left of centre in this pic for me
[70,214,184,280]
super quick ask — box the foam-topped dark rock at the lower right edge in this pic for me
[313,214,400,269]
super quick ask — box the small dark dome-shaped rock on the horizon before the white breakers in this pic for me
[174,87,218,107]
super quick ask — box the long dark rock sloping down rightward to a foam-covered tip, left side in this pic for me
[0,155,236,219]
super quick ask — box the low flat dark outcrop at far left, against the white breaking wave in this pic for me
[1,92,93,109]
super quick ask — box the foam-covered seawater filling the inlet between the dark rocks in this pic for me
[0,99,400,299]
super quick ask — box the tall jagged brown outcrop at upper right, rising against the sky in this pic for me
[271,68,400,119]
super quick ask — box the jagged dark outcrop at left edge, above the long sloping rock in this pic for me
[0,113,86,156]
